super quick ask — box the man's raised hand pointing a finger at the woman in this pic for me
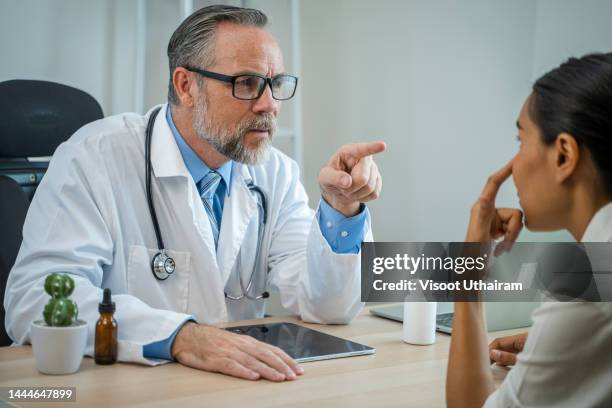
[319,142,386,217]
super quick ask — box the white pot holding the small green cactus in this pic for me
[30,320,87,374]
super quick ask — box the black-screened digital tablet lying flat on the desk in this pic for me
[226,323,376,363]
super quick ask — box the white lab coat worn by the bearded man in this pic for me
[4,105,372,364]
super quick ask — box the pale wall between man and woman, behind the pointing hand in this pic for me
[302,0,536,241]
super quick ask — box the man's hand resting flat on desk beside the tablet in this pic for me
[172,322,304,382]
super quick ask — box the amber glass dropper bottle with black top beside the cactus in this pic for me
[94,288,117,364]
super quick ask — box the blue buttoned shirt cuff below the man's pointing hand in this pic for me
[319,198,370,254]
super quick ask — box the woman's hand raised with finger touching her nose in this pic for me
[465,161,523,255]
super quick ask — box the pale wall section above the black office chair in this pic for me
[0,0,113,112]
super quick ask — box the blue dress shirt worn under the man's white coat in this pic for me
[143,105,369,360]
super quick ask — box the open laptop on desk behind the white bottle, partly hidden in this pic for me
[370,302,540,334]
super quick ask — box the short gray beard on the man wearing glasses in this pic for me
[193,95,277,165]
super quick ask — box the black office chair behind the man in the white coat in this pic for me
[0,80,103,346]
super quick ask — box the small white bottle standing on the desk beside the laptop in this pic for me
[402,302,437,346]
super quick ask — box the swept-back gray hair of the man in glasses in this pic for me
[168,4,268,105]
